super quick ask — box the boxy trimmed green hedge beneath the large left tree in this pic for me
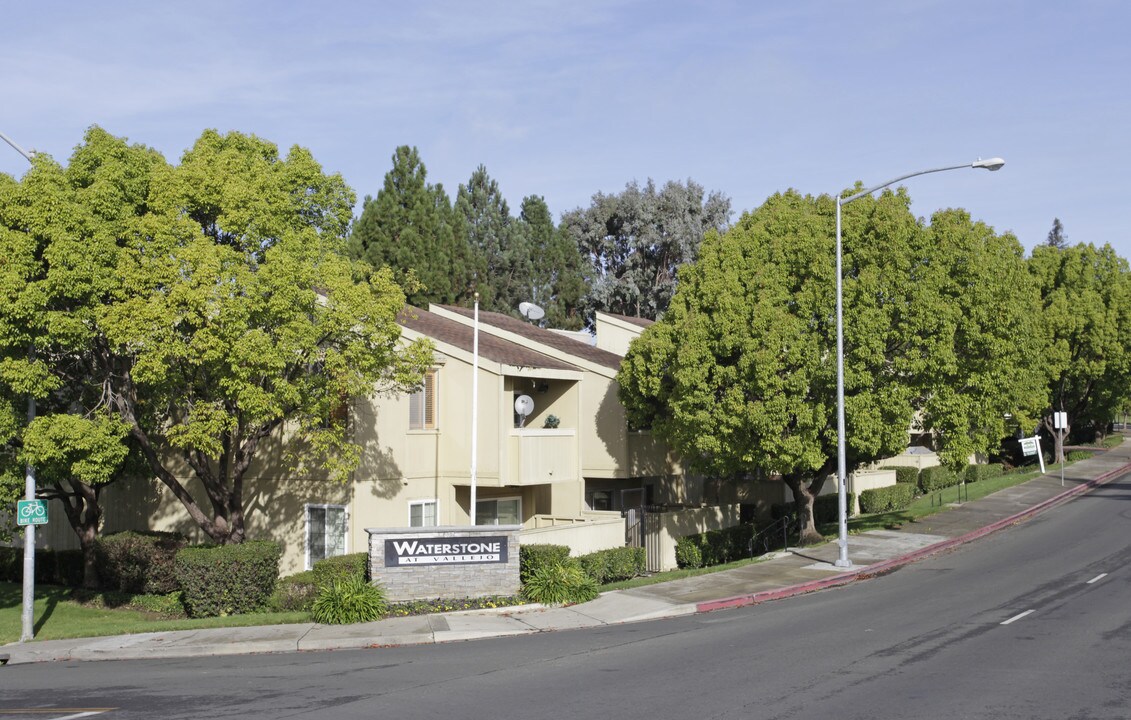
[175,540,283,617]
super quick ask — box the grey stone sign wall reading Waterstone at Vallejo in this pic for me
[365,524,523,602]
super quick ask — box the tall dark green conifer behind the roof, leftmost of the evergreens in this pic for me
[349,146,478,305]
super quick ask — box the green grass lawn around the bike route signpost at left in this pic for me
[0,582,310,644]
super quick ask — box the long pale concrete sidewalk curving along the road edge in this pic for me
[8,442,1131,674]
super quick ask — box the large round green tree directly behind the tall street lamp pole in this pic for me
[618,191,918,541]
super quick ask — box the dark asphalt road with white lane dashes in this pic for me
[0,478,1131,720]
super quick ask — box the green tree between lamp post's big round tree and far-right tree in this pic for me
[908,210,1048,467]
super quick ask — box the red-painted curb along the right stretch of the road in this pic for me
[696,462,1131,613]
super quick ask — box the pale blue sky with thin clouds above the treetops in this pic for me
[0,0,1131,258]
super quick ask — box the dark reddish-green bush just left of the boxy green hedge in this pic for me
[94,530,188,595]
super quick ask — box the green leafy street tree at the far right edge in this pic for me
[1029,243,1131,460]
